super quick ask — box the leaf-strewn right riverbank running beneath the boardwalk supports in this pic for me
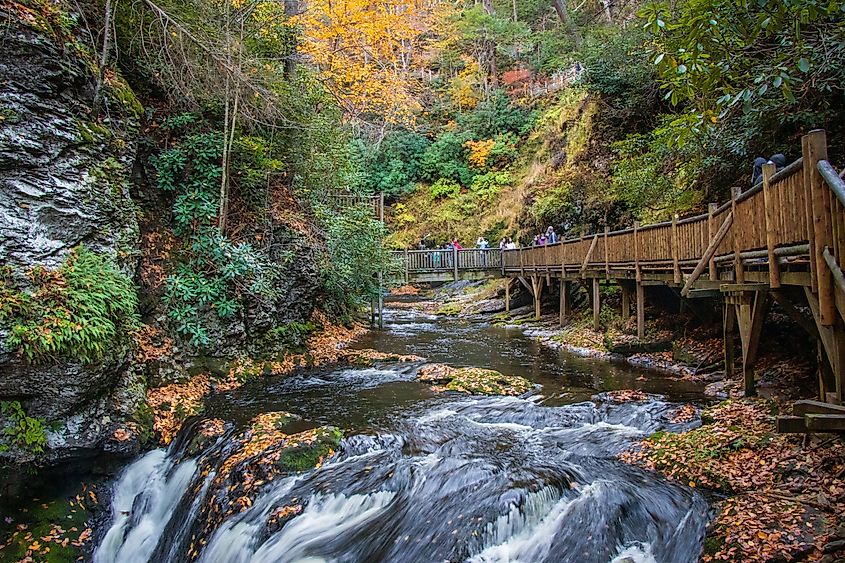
[398,283,845,563]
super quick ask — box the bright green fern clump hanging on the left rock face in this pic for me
[0,246,138,363]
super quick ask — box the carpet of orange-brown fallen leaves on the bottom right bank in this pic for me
[621,399,845,562]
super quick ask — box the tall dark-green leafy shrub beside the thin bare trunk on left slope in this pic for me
[153,122,281,347]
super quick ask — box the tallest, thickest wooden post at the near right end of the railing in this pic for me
[804,129,836,326]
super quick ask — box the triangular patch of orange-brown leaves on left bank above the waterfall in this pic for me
[147,374,211,445]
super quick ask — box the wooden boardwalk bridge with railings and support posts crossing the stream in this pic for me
[397,130,845,432]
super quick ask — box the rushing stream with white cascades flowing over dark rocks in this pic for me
[89,311,708,563]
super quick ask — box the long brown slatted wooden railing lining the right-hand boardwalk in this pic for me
[503,132,828,287]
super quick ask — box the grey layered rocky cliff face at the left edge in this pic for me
[0,2,143,464]
